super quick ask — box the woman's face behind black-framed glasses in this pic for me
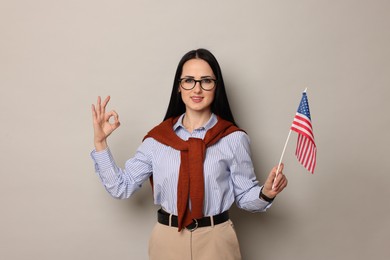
[179,59,216,113]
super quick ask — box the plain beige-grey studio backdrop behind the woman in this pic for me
[0,0,390,260]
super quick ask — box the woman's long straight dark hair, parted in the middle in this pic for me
[164,49,237,125]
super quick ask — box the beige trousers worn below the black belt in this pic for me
[149,220,241,260]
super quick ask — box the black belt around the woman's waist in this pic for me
[157,209,229,232]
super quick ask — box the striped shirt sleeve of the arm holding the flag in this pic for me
[230,132,272,212]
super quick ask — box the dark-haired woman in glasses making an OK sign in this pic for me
[91,49,287,260]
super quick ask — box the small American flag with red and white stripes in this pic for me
[291,92,317,173]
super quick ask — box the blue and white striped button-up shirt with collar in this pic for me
[91,114,271,216]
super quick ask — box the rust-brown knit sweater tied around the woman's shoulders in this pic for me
[144,117,243,231]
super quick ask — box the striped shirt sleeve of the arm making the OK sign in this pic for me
[91,138,153,199]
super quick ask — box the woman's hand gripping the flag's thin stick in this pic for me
[262,164,288,198]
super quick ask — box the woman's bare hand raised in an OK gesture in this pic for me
[92,96,120,151]
